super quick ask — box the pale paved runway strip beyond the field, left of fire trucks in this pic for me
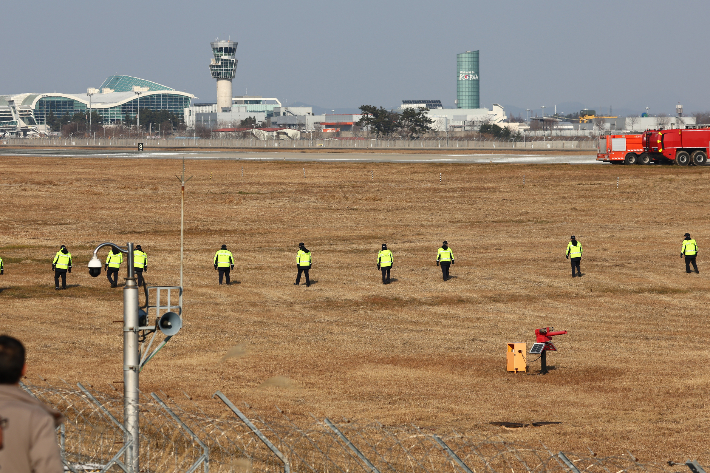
[0,147,597,164]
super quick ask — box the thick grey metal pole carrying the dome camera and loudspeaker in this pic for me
[123,242,140,473]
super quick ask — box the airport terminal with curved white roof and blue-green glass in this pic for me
[0,75,196,135]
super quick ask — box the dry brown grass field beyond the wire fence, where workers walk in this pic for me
[0,154,710,462]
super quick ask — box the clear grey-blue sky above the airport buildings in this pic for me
[0,0,710,114]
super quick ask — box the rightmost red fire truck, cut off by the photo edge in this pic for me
[644,126,710,166]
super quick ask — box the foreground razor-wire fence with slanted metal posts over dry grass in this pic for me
[22,379,704,473]
